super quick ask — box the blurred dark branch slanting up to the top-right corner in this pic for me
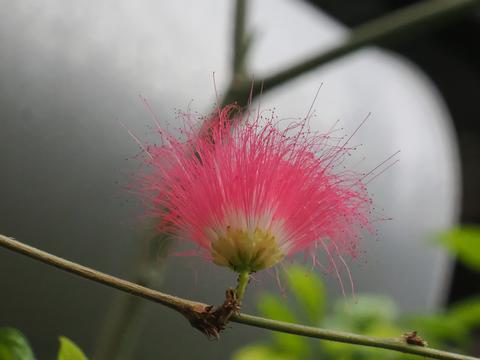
[224,0,480,105]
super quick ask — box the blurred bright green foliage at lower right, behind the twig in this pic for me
[232,233,480,360]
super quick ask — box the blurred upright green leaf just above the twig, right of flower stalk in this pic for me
[286,265,326,325]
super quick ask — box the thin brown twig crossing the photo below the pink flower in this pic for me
[0,235,480,360]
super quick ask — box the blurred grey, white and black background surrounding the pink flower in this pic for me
[0,0,480,359]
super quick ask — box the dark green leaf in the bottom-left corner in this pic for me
[0,328,35,360]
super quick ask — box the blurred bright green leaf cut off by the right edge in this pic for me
[440,226,480,271]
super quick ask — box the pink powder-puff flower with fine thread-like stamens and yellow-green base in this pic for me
[142,105,372,273]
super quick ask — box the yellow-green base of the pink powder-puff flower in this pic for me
[211,227,285,272]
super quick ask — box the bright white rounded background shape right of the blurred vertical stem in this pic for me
[251,0,460,310]
